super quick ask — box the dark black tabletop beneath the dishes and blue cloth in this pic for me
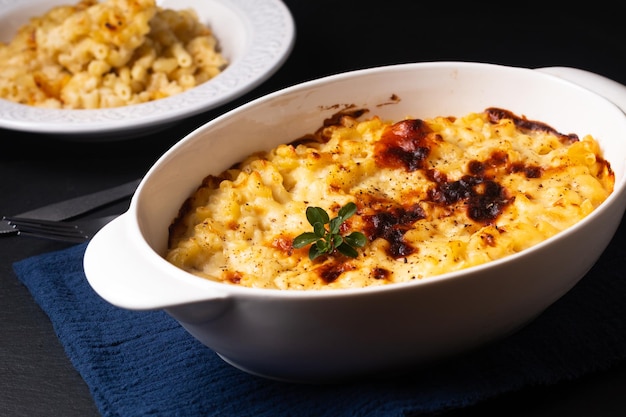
[0,0,626,417]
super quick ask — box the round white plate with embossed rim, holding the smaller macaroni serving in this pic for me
[0,0,295,141]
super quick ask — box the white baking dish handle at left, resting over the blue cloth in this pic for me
[83,213,231,320]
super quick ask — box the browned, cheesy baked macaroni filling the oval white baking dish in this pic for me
[166,108,614,290]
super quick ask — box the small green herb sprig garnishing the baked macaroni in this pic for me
[293,203,367,260]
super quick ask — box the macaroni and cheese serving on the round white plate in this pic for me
[0,0,227,109]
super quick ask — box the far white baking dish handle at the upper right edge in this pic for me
[536,67,626,113]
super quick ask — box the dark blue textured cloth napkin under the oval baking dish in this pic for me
[14,218,626,417]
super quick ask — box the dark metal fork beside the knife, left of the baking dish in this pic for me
[3,215,119,243]
